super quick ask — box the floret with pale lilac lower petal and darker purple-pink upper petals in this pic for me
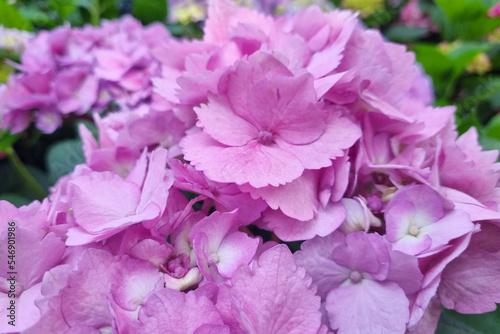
[295,232,422,333]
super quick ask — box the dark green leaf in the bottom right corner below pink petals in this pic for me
[436,307,500,334]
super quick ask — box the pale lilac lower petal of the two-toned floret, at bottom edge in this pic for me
[325,279,409,334]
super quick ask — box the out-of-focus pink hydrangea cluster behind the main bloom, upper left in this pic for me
[0,16,170,133]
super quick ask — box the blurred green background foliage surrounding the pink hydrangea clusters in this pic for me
[0,0,500,334]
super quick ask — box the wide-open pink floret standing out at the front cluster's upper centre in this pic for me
[181,53,359,188]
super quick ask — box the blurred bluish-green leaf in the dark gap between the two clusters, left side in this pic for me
[47,139,85,182]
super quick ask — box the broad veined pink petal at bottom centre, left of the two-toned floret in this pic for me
[221,245,321,334]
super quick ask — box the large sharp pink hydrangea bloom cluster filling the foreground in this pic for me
[0,0,500,334]
